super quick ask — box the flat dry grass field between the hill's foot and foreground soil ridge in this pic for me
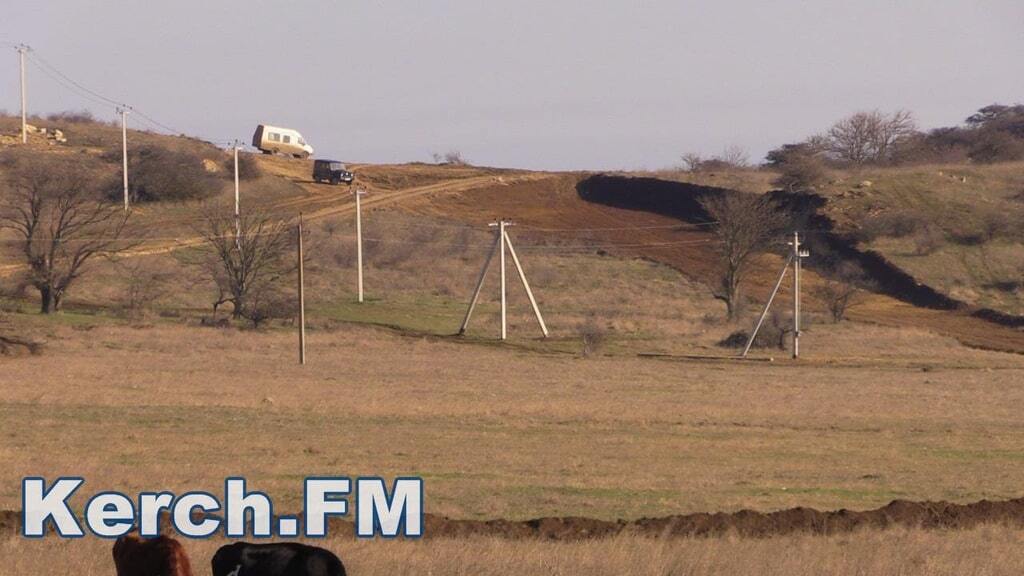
[0,317,1024,519]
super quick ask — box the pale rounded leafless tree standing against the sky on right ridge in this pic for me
[828,110,916,165]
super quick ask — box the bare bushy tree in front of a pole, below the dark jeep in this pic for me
[191,207,296,325]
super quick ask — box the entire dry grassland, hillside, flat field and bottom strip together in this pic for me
[0,116,1024,575]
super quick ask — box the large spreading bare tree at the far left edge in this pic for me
[0,154,136,314]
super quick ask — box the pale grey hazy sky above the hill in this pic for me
[0,0,1024,170]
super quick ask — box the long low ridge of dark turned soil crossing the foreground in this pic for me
[6,498,1024,541]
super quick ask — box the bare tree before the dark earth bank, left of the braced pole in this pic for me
[700,192,787,320]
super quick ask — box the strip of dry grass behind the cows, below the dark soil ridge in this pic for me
[6,527,1024,576]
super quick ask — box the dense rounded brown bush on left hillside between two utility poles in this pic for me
[110,146,223,202]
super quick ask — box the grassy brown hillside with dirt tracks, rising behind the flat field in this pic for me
[0,111,1024,354]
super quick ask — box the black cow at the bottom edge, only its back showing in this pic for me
[211,542,345,576]
